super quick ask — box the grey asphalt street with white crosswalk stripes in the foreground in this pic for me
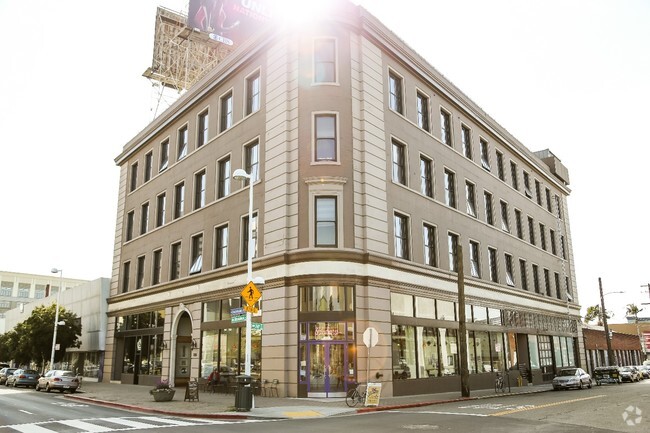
[0,380,650,433]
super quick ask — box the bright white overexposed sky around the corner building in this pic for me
[0,0,650,323]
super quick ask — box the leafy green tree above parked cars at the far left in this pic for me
[6,304,81,369]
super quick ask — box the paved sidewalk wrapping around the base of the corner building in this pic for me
[65,381,553,419]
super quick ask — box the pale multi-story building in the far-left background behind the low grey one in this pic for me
[0,271,88,333]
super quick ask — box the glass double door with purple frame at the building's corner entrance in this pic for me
[307,342,348,397]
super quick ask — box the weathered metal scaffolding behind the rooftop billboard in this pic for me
[142,6,234,116]
